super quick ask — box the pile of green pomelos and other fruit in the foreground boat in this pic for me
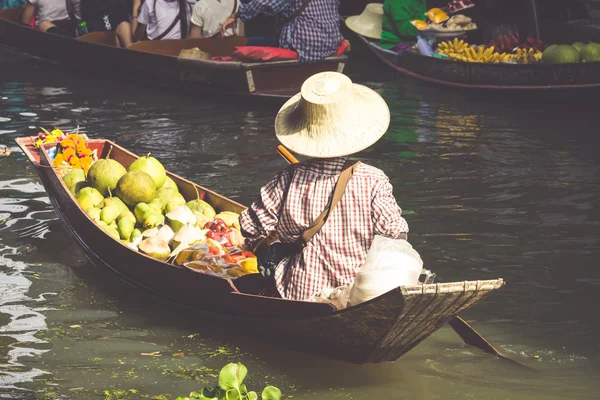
[63,145,258,277]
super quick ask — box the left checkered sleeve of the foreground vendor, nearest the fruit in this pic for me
[240,168,292,239]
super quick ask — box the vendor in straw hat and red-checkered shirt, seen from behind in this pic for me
[240,72,408,300]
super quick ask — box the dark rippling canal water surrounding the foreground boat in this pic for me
[0,47,600,400]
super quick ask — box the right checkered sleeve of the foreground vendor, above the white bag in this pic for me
[371,179,408,240]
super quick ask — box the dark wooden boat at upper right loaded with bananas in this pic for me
[356,35,600,94]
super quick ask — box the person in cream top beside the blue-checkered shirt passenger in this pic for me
[190,0,241,38]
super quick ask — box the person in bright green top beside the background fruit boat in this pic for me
[380,0,427,52]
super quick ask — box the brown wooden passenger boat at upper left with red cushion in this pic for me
[0,8,346,98]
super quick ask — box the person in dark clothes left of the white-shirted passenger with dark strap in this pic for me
[81,0,133,47]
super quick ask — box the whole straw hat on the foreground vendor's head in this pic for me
[275,72,390,158]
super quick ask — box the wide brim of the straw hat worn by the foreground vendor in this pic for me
[275,83,390,158]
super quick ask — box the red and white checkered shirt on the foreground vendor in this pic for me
[240,157,408,300]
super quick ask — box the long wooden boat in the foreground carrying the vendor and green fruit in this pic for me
[16,137,504,363]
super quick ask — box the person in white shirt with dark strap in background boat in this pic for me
[134,0,196,40]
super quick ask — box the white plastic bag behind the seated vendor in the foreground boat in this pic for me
[347,236,423,306]
